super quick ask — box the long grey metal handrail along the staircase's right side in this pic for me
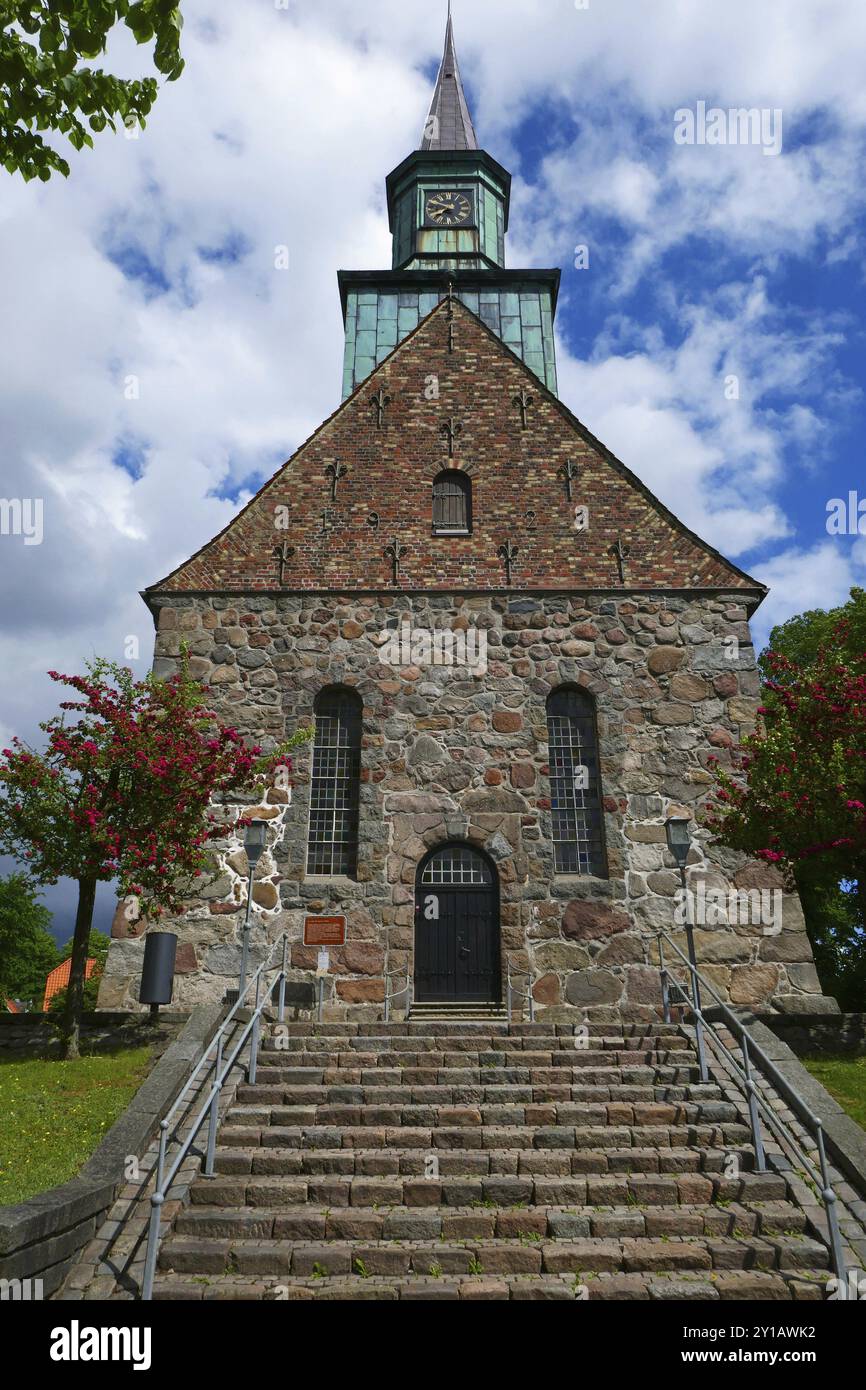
[657,931,847,1284]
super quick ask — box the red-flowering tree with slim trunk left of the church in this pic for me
[0,660,309,1056]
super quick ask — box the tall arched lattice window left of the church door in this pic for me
[307,685,363,876]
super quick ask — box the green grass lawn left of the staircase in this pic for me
[0,1047,150,1207]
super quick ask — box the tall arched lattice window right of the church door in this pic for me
[548,685,607,878]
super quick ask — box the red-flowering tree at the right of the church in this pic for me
[708,624,866,909]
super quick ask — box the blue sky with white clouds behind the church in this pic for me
[0,0,866,935]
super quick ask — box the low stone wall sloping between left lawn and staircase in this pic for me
[0,1005,222,1298]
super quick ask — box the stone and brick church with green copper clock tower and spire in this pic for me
[100,13,826,1020]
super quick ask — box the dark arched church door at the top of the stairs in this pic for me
[416,845,502,1004]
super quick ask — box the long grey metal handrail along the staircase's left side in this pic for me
[142,933,289,1302]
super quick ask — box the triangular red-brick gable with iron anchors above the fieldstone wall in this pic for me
[147,302,766,605]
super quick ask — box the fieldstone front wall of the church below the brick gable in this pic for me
[100,591,826,1019]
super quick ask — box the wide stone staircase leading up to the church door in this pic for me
[154,1020,845,1300]
